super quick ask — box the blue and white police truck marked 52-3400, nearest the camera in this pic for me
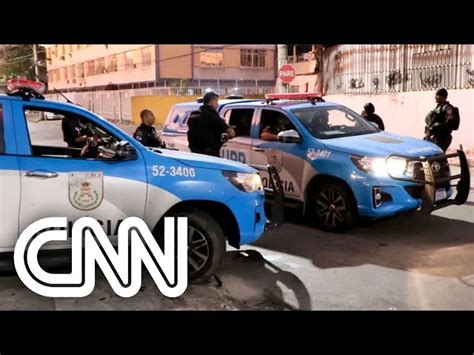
[0,80,283,280]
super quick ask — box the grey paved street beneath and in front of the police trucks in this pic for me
[0,119,474,310]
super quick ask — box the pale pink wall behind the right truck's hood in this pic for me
[325,89,474,160]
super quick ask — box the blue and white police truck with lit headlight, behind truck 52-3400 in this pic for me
[162,93,470,231]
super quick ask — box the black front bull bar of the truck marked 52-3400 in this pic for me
[250,164,285,231]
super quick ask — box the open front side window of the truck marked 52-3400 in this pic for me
[24,107,118,159]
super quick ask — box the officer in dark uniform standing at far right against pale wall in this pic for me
[424,88,454,152]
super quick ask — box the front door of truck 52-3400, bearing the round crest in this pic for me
[14,101,147,247]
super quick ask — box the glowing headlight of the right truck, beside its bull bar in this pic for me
[351,155,407,177]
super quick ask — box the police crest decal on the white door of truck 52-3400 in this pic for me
[69,172,104,211]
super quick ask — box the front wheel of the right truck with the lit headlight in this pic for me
[312,183,355,232]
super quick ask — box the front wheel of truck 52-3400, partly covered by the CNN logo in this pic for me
[157,209,226,283]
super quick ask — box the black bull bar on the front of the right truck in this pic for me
[389,147,471,214]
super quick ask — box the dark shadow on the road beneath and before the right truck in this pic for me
[255,207,474,284]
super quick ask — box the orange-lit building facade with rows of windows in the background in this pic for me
[45,44,276,91]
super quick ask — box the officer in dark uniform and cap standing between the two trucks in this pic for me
[188,91,235,157]
